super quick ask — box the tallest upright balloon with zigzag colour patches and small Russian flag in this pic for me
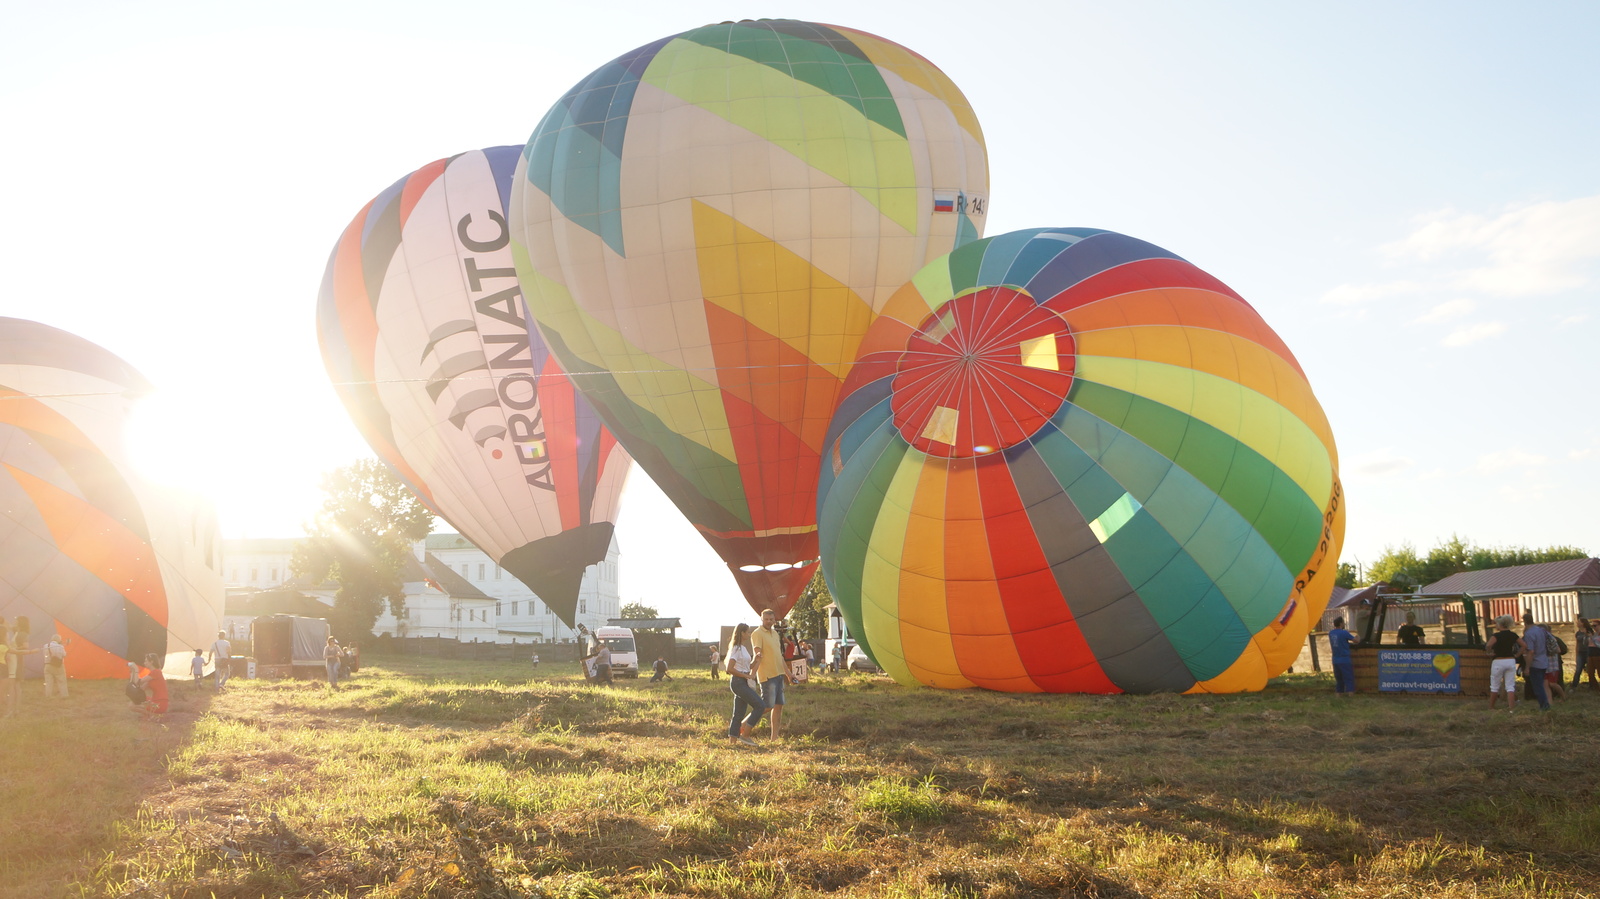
[510,19,989,613]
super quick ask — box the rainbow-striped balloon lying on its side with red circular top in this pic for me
[818,229,1344,693]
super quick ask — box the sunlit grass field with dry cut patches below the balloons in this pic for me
[0,649,1600,899]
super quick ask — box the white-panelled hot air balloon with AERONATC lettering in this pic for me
[317,147,629,625]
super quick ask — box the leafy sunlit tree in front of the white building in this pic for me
[290,459,434,640]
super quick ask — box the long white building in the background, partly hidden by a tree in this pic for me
[222,534,622,643]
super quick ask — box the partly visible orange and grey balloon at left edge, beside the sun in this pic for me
[0,318,224,678]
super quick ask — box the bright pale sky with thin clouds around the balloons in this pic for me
[0,0,1600,635]
